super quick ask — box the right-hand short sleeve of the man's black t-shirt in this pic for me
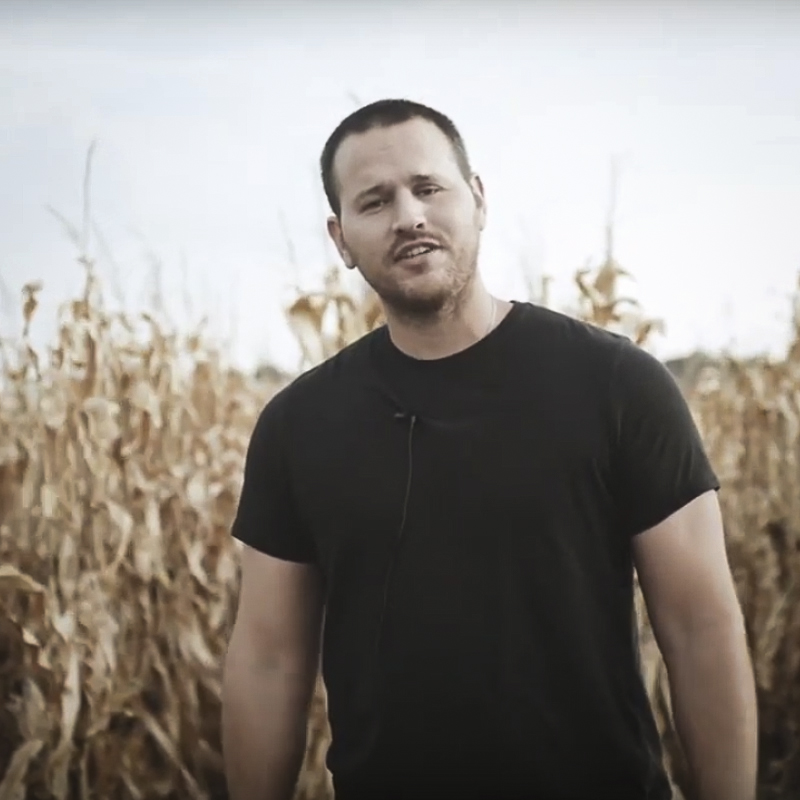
[611,339,719,536]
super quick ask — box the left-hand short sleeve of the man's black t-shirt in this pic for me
[232,390,316,563]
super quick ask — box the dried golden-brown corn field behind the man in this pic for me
[0,263,800,800]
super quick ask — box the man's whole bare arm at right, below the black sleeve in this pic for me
[633,491,758,800]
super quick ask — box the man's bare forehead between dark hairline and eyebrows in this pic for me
[333,119,460,195]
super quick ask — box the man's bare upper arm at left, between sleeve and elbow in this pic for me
[231,545,323,674]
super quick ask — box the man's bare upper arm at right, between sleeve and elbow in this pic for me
[632,491,740,654]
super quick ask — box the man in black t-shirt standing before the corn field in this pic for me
[223,100,756,800]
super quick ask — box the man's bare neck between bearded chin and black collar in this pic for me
[385,277,507,360]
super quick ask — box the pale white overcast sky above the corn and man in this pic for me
[0,0,800,376]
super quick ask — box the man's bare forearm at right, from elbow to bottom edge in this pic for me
[665,624,758,800]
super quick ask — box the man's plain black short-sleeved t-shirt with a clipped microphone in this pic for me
[234,303,718,800]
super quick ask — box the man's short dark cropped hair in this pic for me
[320,100,472,217]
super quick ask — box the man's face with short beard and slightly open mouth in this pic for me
[328,119,485,319]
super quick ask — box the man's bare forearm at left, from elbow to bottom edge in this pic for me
[222,657,316,800]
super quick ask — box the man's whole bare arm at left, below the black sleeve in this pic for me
[222,546,323,800]
